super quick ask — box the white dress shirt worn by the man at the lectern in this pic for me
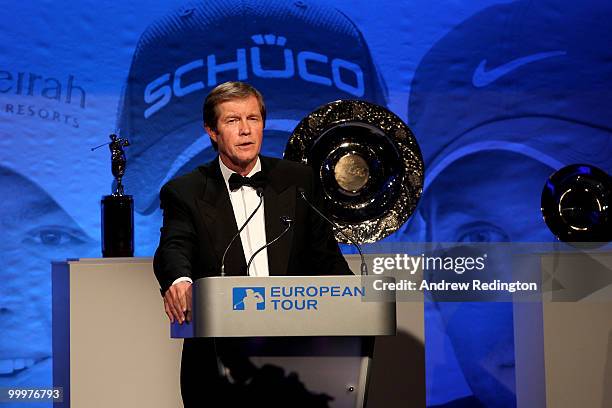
[172,157,270,285]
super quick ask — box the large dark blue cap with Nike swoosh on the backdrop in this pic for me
[408,0,612,187]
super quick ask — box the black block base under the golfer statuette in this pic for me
[100,195,134,258]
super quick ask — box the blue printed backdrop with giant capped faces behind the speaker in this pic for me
[0,0,612,406]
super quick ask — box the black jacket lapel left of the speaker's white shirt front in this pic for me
[198,158,246,275]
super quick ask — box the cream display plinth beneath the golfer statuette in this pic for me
[52,258,182,408]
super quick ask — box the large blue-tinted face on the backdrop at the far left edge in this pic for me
[0,167,99,387]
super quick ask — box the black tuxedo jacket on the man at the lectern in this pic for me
[154,156,352,293]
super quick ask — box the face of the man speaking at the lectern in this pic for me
[206,96,263,173]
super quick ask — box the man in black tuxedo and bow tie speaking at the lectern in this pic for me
[154,82,351,407]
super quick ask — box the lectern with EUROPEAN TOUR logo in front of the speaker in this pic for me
[171,276,396,408]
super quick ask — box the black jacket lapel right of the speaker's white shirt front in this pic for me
[260,156,296,275]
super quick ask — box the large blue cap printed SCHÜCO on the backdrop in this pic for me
[118,0,386,213]
